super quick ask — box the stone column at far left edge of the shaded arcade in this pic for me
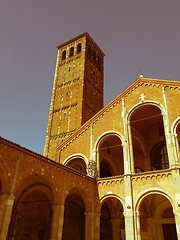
[0,194,15,240]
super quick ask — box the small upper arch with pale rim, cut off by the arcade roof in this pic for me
[63,154,88,174]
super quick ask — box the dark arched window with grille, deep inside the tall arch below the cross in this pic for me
[151,142,169,170]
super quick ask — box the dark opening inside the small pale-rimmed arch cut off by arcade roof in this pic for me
[66,157,87,174]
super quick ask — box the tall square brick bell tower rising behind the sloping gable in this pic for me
[44,33,105,159]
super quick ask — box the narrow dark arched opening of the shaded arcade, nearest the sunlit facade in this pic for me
[62,193,85,240]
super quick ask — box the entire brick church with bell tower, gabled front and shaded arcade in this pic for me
[0,33,180,240]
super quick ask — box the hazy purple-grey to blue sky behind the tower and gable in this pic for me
[0,0,180,154]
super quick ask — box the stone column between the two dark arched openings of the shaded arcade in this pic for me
[51,205,64,240]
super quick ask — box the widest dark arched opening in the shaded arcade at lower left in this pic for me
[8,184,53,240]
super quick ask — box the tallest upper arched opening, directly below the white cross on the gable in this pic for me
[130,104,169,171]
